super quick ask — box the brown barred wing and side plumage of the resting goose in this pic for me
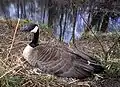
[36,45,101,78]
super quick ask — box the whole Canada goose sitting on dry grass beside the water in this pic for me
[23,24,104,79]
